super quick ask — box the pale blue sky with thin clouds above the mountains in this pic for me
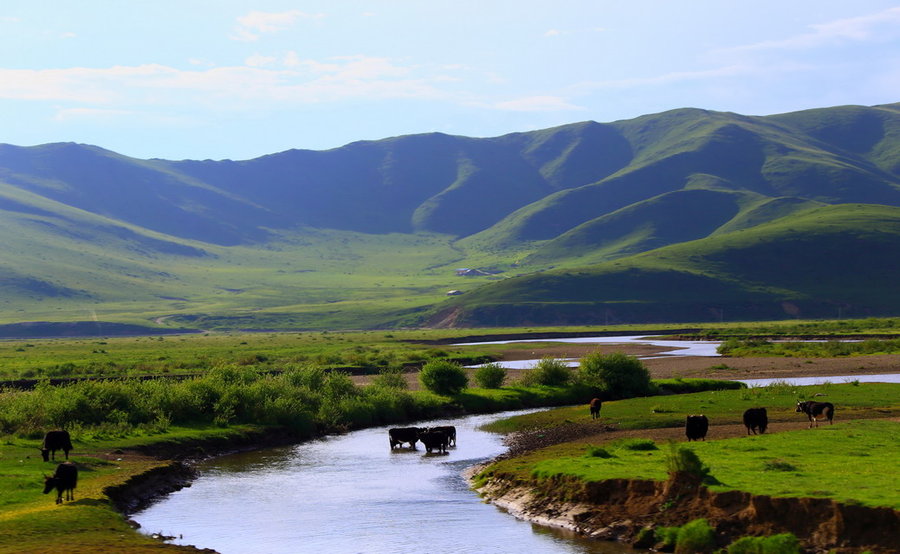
[0,0,900,159]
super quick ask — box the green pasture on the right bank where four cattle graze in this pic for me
[483,383,900,509]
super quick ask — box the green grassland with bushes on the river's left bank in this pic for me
[0,320,897,552]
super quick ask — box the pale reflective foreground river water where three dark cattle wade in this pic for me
[134,412,635,554]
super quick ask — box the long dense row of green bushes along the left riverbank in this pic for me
[0,366,438,435]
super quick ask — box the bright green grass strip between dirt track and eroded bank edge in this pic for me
[532,420,900,510]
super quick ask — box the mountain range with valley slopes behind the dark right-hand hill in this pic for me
[0,104,900,326]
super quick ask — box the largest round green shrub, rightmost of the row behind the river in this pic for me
[578,352,652,398]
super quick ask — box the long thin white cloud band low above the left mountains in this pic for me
[0,57,454,108]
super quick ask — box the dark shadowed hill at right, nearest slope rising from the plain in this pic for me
[428,205,900,327]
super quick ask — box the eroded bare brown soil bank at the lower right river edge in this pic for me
[478,475,900,554]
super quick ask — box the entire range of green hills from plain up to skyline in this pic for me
[0,104,900,330]
